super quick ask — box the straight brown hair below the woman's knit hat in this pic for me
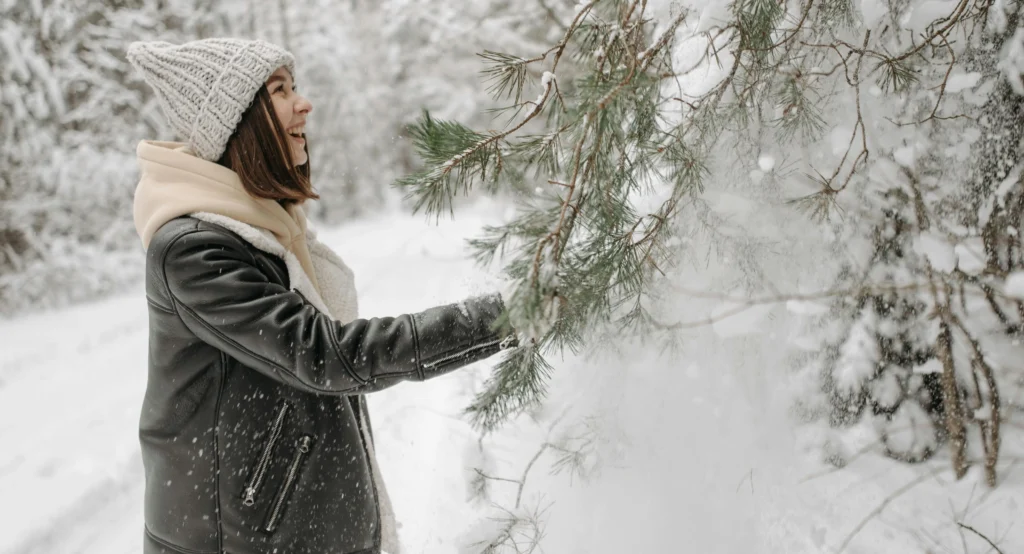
[217,87,319,204]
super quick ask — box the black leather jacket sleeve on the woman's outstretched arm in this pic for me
[163,229,517,394]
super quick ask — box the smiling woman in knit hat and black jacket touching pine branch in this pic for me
[127,39,518,554]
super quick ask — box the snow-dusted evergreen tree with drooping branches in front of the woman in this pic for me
[395,0,1024,484]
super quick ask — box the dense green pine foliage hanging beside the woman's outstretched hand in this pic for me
[395,1,708,430]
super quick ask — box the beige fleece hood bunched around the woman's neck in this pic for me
[133,140,319,289]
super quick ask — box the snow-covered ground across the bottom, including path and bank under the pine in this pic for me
[0,207,1024,554]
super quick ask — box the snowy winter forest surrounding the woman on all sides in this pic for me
[0,0,1024,554]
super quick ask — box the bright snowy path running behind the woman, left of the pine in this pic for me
[0,206,507,554]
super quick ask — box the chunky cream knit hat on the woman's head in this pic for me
[127,38,295,162]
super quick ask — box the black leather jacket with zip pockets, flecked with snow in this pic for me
[139,216,516,554]
